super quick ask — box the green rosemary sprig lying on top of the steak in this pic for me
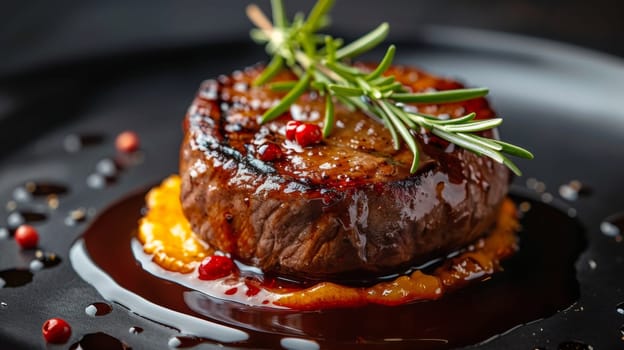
[247,0,533,175]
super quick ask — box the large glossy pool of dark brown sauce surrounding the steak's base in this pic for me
[71,192,585,349]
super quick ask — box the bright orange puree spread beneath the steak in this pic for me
[138,175,519,310]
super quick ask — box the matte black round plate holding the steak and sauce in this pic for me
[0,28,624,349]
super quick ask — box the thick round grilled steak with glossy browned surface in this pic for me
[180,65,509,280]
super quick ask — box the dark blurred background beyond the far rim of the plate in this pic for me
[0,0,624,77]
